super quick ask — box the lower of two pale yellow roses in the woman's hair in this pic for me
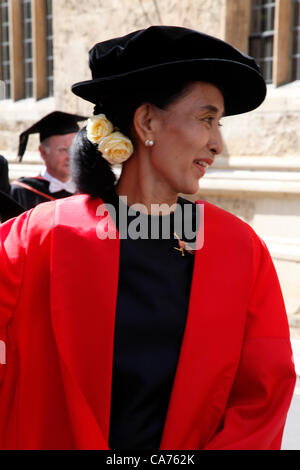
[98,132,133,165]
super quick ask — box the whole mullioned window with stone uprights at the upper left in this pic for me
[0,0,53,101]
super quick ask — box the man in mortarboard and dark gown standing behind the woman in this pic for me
[11,111,86,210]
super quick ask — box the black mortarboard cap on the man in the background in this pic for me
[18,111,87,161]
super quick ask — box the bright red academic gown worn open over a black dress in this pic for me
[0,195,295,450]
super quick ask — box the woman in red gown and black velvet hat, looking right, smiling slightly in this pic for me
[0,26,295,450]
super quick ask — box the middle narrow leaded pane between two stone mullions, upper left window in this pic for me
[22,0,33,98]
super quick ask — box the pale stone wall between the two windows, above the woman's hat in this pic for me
[54,0,225,113]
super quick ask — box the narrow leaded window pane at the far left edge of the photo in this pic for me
[0,0,11,98]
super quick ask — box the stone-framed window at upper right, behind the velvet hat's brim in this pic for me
[224,0,300,87]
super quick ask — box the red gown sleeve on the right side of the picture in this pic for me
[205,236,296,450]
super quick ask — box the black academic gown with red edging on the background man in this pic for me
[11,176,73,210]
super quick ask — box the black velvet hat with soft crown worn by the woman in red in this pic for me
[72,26,266,116]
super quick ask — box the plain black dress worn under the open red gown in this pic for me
[105,194,197,450]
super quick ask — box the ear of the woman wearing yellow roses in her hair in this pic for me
[133,103,157,143]
